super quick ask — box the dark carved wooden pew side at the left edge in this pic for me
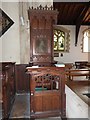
[0,62,16,120]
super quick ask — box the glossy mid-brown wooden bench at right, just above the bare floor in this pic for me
[66,69,90,80]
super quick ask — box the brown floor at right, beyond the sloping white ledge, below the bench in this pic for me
[66,80,90,106]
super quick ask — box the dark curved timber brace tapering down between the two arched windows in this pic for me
[75,1,90,46]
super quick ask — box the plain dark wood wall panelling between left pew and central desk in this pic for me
[15,64,29,93]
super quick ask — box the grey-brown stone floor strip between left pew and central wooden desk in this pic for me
[10,94,30,118]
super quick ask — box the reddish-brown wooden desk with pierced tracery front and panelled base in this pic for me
[27,67,66,118]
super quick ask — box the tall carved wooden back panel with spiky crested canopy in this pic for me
[28,6,58,64]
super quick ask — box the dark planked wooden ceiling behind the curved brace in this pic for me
[53,2,90,25]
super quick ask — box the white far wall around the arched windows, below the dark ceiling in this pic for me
[54,25,88,63]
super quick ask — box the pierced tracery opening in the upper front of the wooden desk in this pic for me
[35,73,60,91]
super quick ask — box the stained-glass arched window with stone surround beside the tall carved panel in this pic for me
[54,26,70,53]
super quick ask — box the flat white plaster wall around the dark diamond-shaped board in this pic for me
[0,2,20,63]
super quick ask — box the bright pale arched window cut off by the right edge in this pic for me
[82,28,90,52]
